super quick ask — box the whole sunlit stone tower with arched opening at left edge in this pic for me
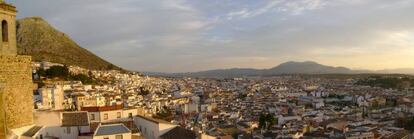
[0,0,35,139]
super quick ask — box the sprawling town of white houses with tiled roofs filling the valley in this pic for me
[30,62,414,139]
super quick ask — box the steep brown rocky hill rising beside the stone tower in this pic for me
[16,17,120,69]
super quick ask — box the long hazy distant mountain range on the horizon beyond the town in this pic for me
[145,61,414,77]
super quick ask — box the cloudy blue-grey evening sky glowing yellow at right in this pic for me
[6,0,414,72]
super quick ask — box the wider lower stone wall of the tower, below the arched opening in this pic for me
[0,55,34,129]
